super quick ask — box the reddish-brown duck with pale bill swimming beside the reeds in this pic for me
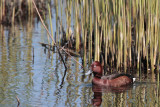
[85,61,136,87]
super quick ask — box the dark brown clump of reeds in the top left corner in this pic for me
[0,0,50,26]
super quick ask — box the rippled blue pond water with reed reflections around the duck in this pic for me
[0,0,160,107]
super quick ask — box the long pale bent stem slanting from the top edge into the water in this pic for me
[32,0,83,68]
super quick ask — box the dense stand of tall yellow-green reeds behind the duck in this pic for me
[56,0,160,71]
